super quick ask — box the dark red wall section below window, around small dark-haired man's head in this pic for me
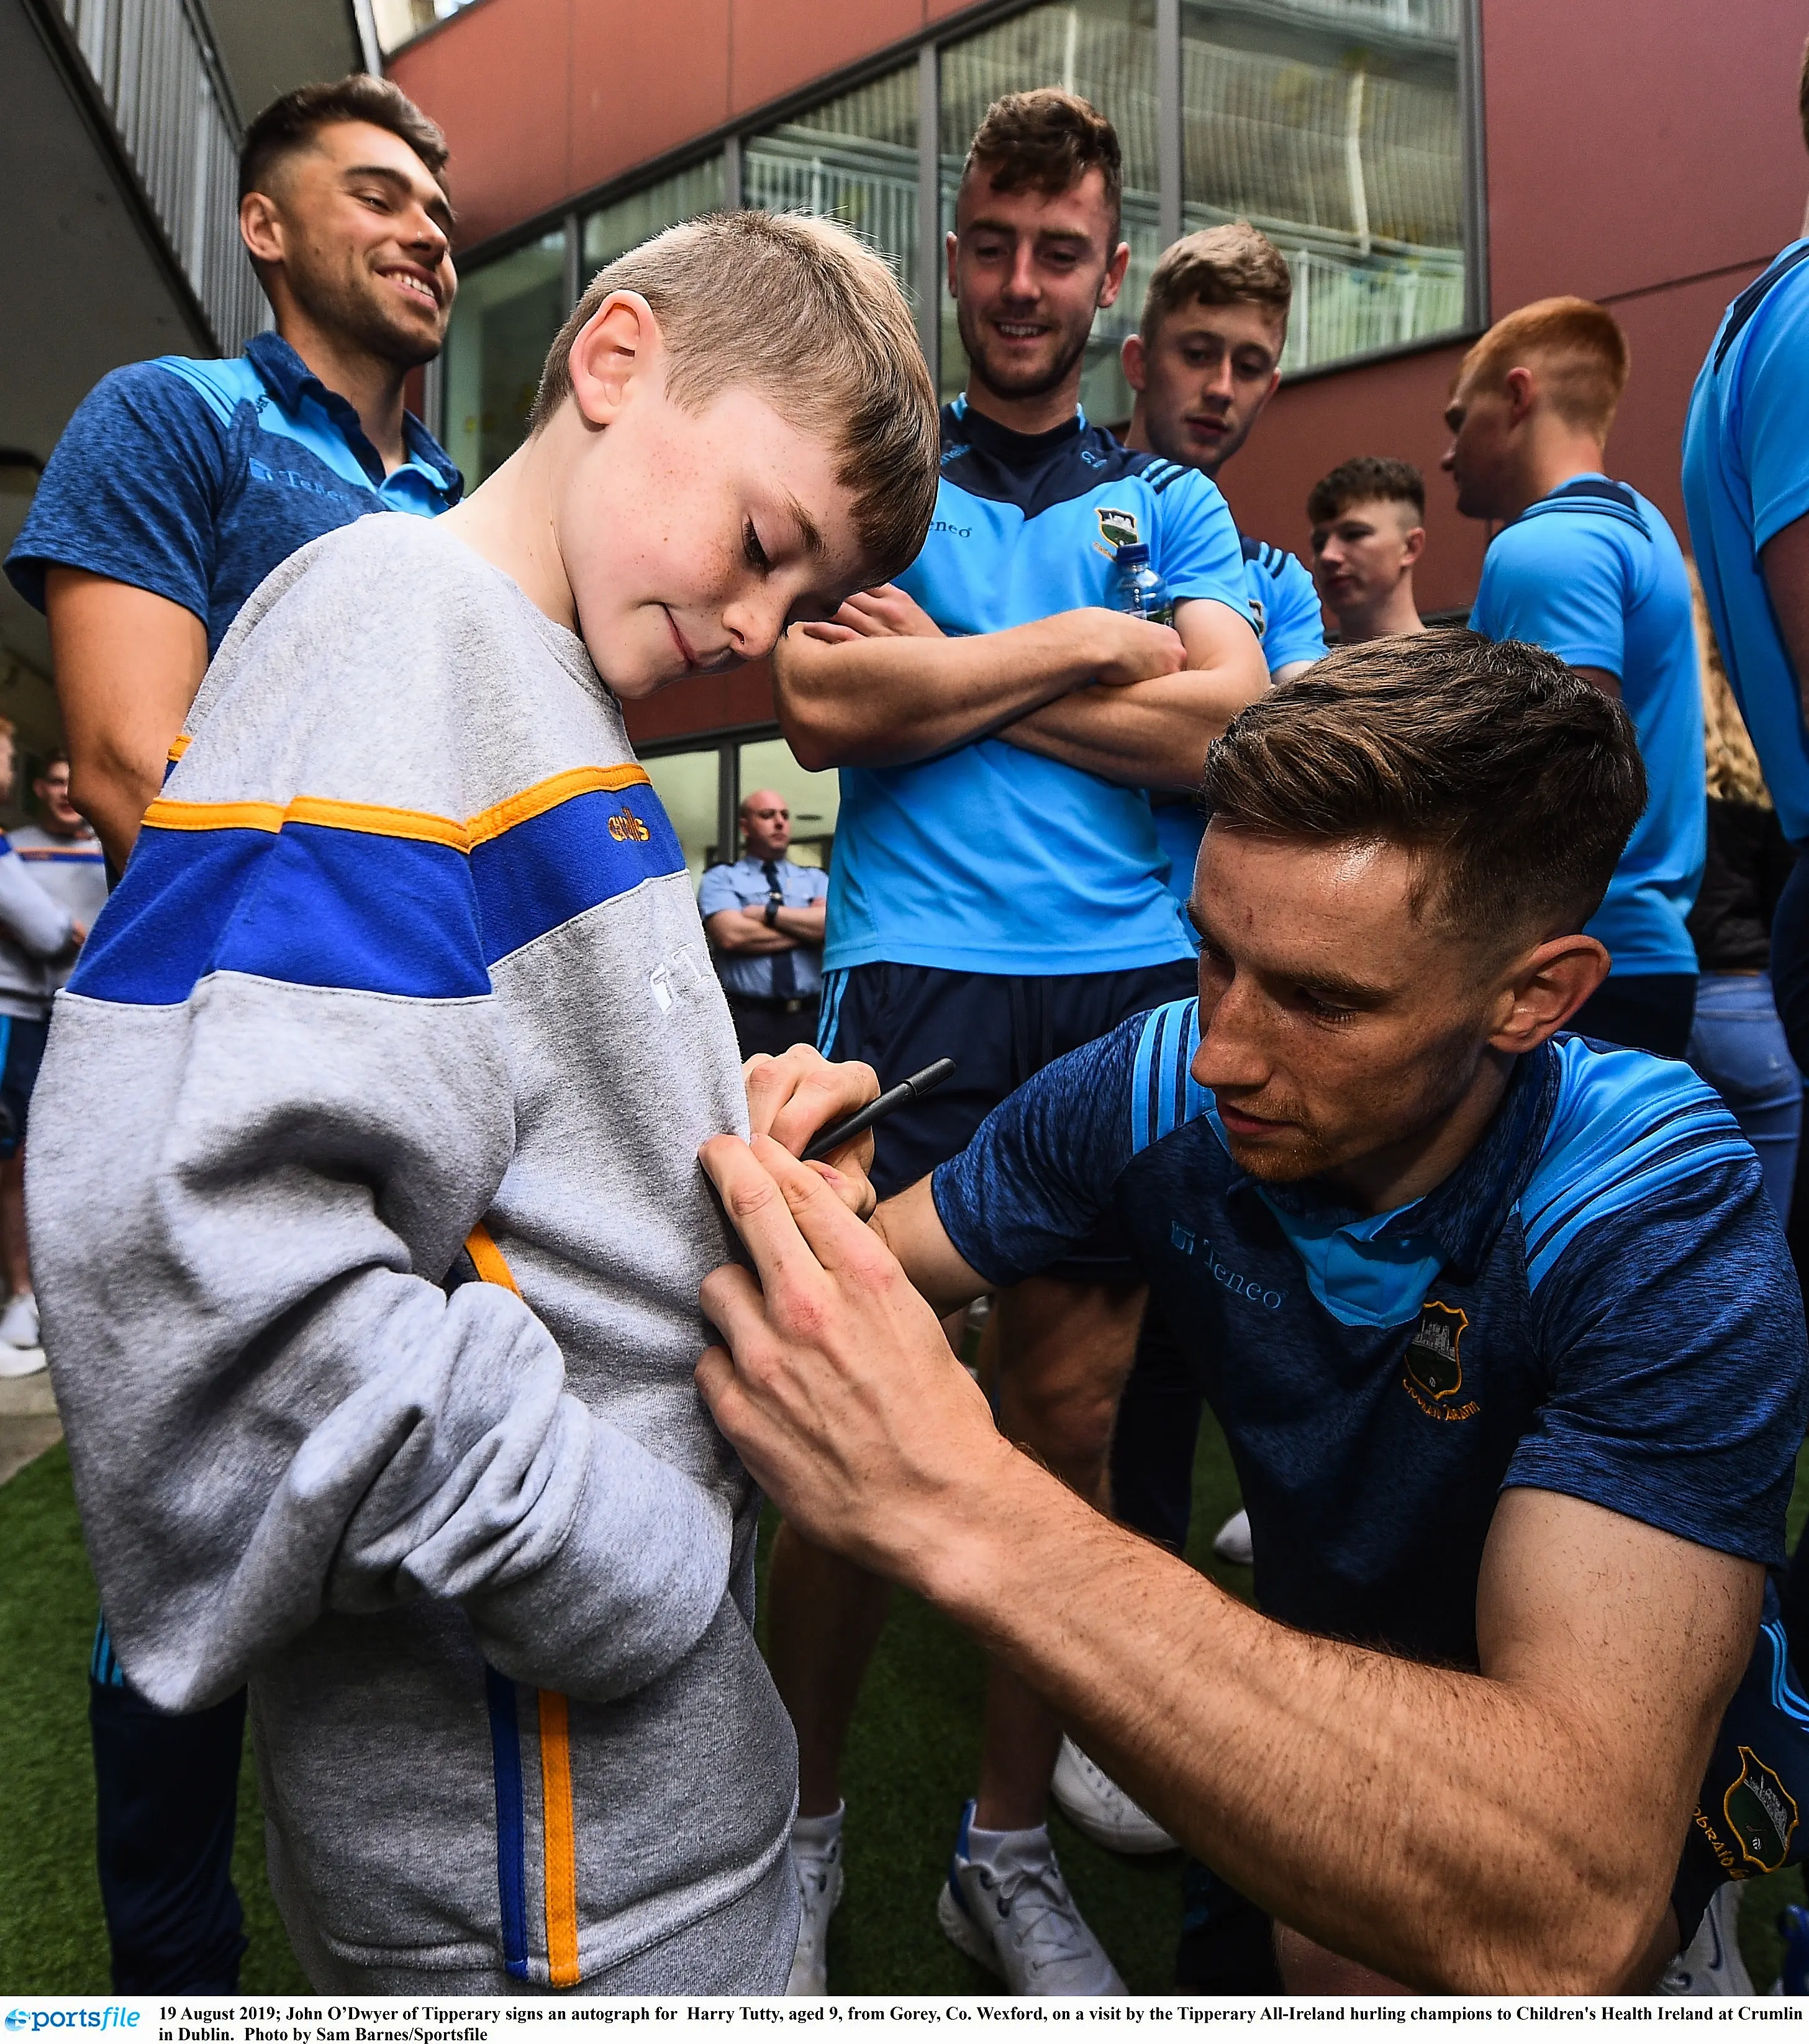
[1218,345,1484,611]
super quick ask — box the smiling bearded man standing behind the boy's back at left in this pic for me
[6,76,462,1995]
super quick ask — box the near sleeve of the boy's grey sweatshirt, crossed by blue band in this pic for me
[30,543,732,1711]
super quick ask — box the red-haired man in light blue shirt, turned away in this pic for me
[1443,298,1709,1056]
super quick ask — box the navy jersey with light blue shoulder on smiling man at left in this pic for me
[6,333,464,658]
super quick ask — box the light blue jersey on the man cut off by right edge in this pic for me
[1684,241,1809,844]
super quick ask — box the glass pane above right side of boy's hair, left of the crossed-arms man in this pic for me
[742,63,918,304]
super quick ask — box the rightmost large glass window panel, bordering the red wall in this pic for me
[1182,0,1464,370]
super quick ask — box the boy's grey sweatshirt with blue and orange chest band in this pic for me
[29,515,795,1993]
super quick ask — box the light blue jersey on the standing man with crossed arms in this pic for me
[823,399,1253,975]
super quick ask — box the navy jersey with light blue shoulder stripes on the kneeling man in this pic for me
[932,1002,1809,1666]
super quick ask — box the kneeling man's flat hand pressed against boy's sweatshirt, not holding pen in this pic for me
[697,1136,1020,1574]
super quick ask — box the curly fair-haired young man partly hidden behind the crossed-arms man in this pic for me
[1124,220,1325,901]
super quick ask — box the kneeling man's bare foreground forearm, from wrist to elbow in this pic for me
[912,1457,1687,1993]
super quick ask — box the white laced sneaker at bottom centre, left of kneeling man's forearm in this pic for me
[936,1803,1124,1995]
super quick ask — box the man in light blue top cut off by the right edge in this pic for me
[1684,68,1809,1071]
